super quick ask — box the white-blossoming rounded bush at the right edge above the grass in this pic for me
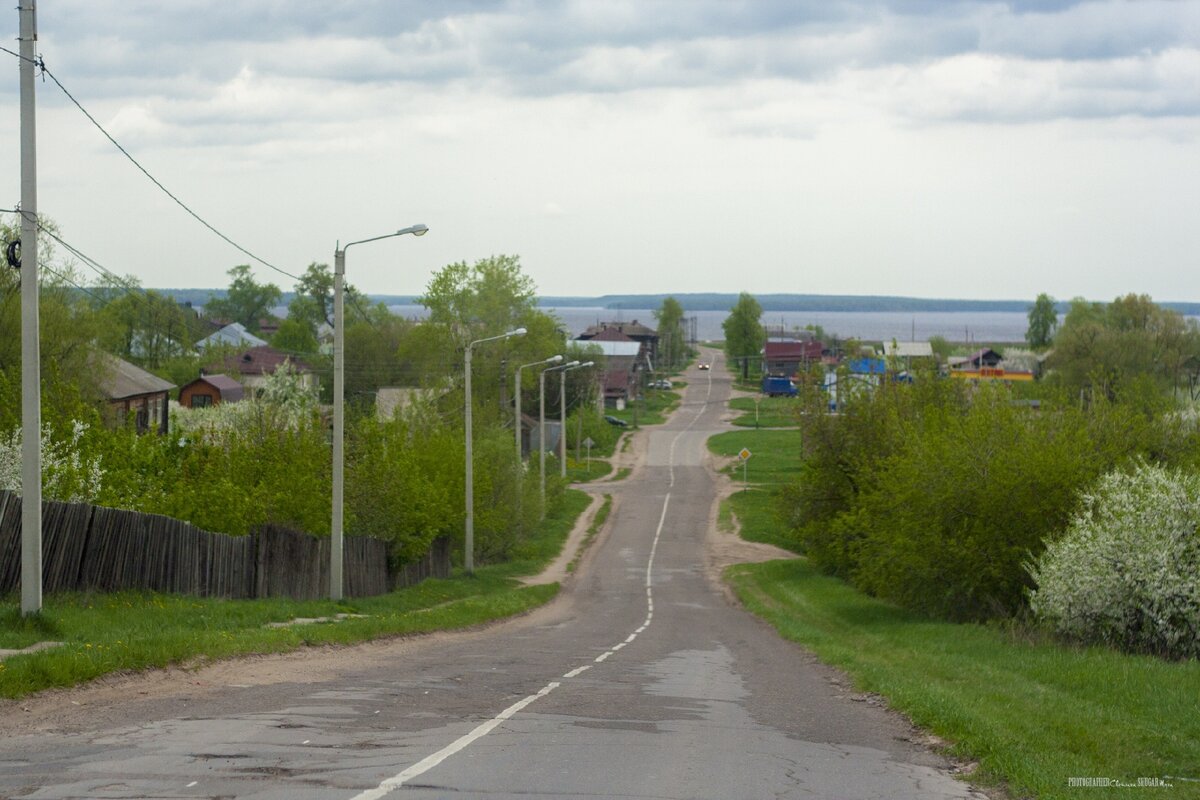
[1028,463,1200,658]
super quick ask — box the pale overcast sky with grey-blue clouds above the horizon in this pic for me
[0,0,1200,301]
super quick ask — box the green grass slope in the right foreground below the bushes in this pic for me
[726,559,1200,800]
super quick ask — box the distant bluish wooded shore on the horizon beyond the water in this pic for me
[156,289,1200,317]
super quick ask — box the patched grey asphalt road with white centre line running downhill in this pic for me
[0,352,982,800]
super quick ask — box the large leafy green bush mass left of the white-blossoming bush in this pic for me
[782,375,1180,620]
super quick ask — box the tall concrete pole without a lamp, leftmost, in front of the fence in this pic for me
[18,0,42,616]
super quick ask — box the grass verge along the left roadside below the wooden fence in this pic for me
[0,491,589,698]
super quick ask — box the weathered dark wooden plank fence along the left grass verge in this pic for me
[0,492,450,600]
